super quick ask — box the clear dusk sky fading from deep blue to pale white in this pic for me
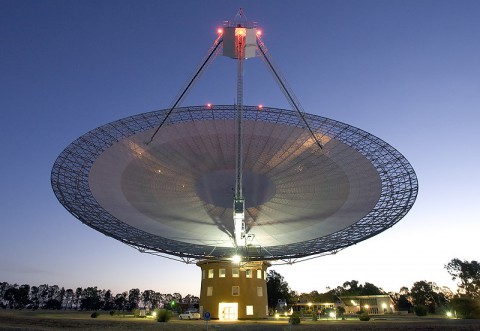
[0,0,480,295]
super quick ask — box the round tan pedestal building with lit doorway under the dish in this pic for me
[197,260,270,320]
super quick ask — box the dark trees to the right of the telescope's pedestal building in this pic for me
[267,258,480,318]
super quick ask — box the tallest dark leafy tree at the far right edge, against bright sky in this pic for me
[445,259,480,298]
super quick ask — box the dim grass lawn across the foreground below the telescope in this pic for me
[0,310,480,331]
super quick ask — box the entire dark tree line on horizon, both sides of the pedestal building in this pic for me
[0,259,480,318]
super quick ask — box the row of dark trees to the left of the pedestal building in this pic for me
[0,282,200,311]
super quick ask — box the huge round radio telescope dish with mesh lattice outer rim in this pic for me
[51,105,418,262]
